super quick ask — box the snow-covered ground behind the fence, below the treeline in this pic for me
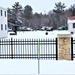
[8,30,75,39]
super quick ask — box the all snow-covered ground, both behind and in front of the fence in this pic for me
[0,31,75,75]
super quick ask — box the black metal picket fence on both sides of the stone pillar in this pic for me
[0,38,75,60]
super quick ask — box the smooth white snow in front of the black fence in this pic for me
[0,59,75,75]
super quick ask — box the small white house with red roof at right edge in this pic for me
[68,16,75,33]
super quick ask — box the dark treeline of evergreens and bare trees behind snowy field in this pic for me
[8,2,75,29]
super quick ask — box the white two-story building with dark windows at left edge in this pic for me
[0,7,8,38]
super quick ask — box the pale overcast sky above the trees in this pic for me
[0,0,75,13]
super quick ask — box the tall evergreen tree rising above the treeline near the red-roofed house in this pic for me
[53,2,66,28]
